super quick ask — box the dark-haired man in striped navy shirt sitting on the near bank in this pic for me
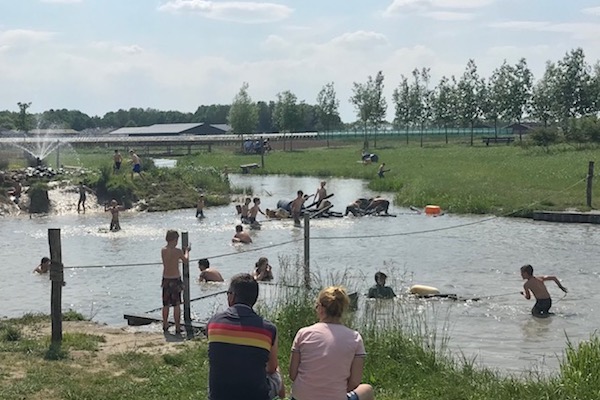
[207,274,284,400]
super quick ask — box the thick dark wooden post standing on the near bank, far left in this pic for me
[48,229,64,347]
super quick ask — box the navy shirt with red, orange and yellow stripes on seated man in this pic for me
[207,304,277,400]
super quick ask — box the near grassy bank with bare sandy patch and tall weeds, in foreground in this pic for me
[0,289,600,400]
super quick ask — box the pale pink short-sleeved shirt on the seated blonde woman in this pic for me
[292,322,367,400]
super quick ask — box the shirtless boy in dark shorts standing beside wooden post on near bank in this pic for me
[160,230,191,334]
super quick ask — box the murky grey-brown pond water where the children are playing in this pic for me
[0,175,600,372]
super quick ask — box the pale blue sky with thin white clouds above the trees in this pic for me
[0,0,600,122]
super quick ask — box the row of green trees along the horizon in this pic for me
[0,48,600,144]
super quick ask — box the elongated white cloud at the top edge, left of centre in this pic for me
[158,0,293,23]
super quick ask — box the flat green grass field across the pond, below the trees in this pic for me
[175,141,600,215]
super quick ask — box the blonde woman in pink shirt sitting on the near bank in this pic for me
[290,286,375,400]
